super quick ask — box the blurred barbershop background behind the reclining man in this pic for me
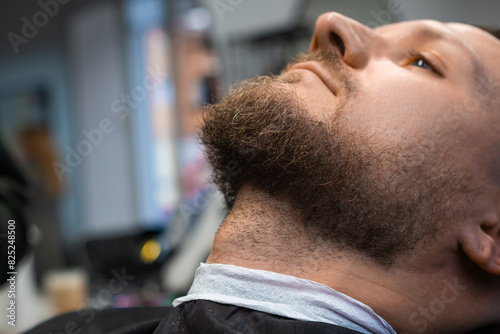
[0,0,500,333]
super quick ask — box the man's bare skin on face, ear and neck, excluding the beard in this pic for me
[207,13,500,333]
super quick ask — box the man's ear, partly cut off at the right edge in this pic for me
[459,215,500,276]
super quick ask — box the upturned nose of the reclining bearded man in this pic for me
[310,12,375,68]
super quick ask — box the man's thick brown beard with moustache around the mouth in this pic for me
[200,52,470,265]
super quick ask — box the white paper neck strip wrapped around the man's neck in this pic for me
[173,263,396,334]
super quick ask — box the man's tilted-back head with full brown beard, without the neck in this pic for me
[201,13,500,275]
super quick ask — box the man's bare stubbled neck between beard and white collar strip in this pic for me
[207,187,496,333]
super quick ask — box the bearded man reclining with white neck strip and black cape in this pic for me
[26,13,500,334]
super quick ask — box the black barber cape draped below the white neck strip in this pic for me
[25,300,359,334]
